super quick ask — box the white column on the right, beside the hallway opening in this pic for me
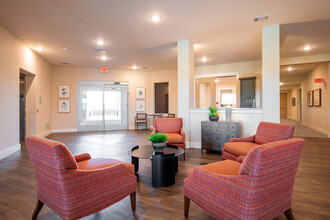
[262,25,280,123]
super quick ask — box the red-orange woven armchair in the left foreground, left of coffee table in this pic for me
[26,136,136,219]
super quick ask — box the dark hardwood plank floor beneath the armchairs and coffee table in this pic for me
[0,131,330,220]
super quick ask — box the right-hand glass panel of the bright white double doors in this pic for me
[104,85,128,130]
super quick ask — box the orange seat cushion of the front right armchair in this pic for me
[188,160,242,177]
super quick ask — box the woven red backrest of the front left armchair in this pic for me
[25,136,77,190]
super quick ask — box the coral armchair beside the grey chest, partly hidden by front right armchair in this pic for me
[222,122,294,161]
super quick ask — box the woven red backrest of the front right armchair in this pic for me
[240,138,305,180]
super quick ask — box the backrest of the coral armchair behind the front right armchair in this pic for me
[255,122,294,144]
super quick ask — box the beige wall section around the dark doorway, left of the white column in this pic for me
[150,69,178,116]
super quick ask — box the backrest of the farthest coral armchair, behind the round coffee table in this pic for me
[155,118,182,133]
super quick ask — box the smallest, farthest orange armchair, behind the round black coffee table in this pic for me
[152,118,186,160]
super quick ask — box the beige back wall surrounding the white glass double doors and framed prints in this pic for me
[52,67,153,132]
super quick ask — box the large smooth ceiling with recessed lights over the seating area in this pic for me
[0,0,330,70]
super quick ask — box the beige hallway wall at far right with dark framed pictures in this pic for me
[302,63,330,133]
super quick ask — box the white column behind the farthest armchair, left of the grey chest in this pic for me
[178,40,194,147]
